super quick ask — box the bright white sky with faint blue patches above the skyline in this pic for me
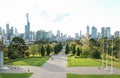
[0,0,120,36]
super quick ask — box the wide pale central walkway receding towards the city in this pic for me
[30,49,67,78]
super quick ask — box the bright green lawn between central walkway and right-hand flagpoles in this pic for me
[67,57,101,67]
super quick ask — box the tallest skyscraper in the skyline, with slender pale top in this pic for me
[25,13,30,41]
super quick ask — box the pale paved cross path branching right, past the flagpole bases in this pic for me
[67,67,120,74]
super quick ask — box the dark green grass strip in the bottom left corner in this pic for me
[0,73,32,78]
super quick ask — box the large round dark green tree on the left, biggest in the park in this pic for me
[8,37,28,57]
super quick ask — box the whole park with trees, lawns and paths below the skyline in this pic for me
[0,37,120,78]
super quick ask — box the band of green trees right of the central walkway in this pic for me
[65,37,120,59]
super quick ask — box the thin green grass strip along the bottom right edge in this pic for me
[67,74,120,78]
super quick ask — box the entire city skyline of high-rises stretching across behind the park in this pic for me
[0,13,120,44]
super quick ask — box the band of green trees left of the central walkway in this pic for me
[4,37,62,60]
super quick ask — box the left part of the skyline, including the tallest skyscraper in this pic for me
[0,13,67,44]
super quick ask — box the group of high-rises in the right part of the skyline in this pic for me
[75,26,120,40]
